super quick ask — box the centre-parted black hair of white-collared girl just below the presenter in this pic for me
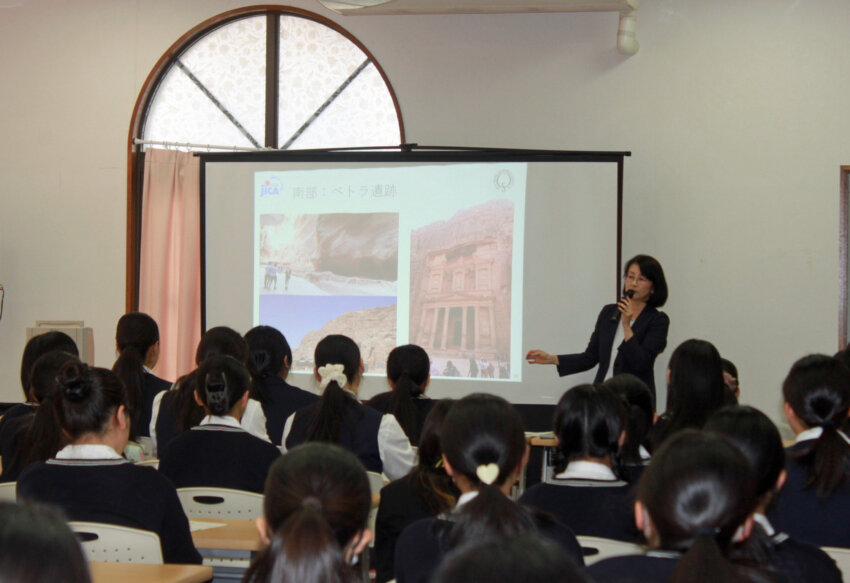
[554,385,625,473]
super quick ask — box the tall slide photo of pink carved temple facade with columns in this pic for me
[410,199,514,378]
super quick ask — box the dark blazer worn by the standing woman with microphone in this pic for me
[558,304,670,401]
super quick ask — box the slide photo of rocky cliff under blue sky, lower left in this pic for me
[260,294,397,374]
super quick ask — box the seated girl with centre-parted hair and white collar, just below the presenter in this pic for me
[519,385,637,542]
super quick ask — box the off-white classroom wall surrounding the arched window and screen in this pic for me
[0,0,850,436]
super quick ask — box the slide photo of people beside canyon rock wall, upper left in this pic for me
[255,213,398,296]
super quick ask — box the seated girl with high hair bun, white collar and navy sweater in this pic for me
[17,362,201,563]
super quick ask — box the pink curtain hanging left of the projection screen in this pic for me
[139,149,201,381]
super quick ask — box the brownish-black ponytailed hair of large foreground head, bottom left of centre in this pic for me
[243,443,372,583]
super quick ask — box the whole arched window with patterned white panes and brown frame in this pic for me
[127,6,404,310]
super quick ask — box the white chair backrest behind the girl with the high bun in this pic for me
[68,522,162,565]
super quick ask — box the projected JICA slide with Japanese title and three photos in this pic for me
[253,163,527,381]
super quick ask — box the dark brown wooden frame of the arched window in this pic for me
[125,4,406,312]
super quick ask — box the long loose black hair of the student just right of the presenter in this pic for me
[652,339,726,449]
